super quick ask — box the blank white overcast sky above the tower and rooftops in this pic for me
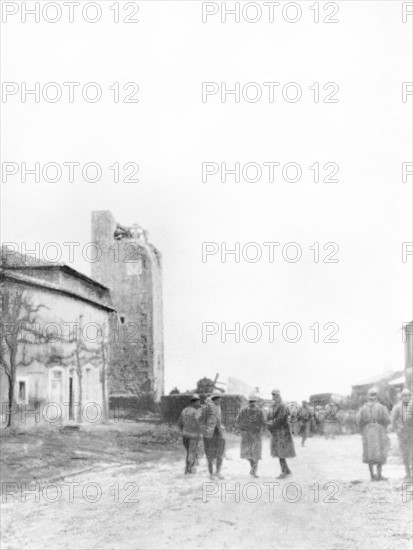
[2,1,412,400]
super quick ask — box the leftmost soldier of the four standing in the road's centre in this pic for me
[178,393,201,474]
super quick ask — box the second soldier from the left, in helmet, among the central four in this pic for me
[201,390,225,479]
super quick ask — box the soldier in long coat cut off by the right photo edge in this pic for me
[391,388,413,481]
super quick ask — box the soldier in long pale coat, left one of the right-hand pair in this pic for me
[357,388,390,481]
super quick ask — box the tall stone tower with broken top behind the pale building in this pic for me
[92,210,164,401]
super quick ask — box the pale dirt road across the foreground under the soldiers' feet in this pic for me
[2,435,413,550]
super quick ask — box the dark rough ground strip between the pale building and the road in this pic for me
[0,421,181,483]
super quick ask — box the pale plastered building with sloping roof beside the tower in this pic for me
[0,248,116,424]
